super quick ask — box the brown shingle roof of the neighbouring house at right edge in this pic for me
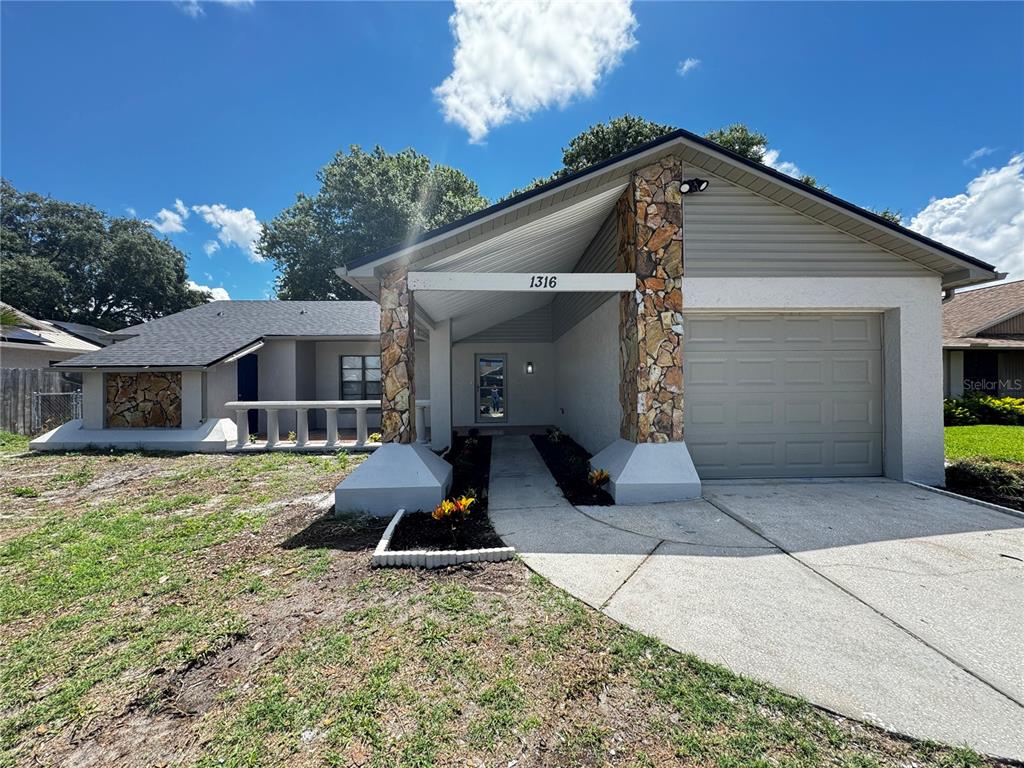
[942,281,1024,349]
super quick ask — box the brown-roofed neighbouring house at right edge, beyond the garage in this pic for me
[942,281,1024,397]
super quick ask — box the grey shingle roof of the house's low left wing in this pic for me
[52,301,380,369]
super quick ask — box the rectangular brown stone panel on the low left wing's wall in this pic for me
[103,371,181,428]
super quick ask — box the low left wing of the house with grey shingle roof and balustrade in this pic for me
[32,301,389,452]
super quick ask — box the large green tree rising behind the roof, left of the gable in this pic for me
[259,145,487,300]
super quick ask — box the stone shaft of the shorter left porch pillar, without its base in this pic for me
[380,267,416,443]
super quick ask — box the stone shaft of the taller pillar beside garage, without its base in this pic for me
[615,157,683,442]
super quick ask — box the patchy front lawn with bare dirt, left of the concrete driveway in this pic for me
[0,454,988,768]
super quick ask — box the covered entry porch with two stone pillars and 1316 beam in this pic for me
[337,155,700,514]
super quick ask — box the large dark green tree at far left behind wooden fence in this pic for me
[0,179,209,331]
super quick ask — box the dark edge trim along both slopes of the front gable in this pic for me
[346,128,996,272]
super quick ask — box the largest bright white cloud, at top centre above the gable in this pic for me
[434,0,637,142]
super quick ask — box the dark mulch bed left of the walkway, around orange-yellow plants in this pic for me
[390,435,505,551]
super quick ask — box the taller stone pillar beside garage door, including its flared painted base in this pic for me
[590,157,700,504]
